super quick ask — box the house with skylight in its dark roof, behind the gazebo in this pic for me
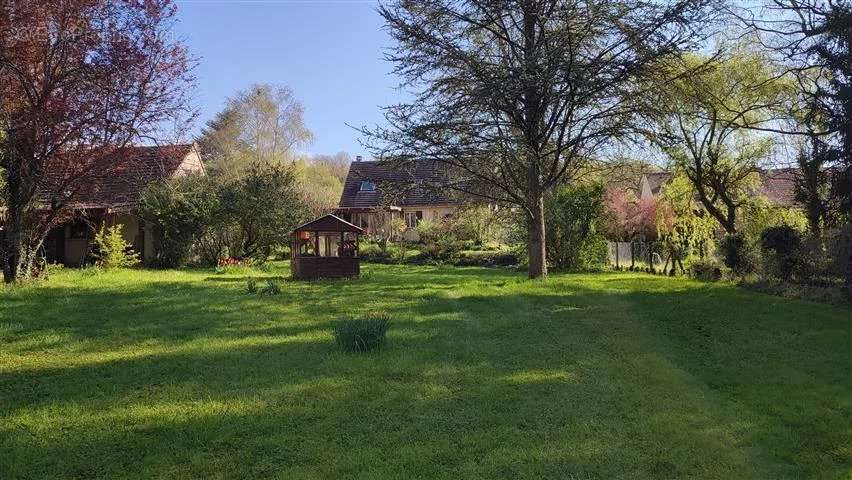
[335,157,461,240]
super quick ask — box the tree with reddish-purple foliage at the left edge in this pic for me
[0,0,193,282]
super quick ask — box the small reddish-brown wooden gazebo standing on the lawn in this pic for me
[290,215,364,279]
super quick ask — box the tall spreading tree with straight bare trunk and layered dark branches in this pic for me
[363,0,714,278]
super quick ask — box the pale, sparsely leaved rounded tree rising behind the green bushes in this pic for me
[198,84,313,175]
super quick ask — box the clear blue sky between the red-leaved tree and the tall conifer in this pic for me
[174,0,401,158]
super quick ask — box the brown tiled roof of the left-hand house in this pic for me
[42,144,193,209]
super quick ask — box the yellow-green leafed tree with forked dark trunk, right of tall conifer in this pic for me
[648,46,789,234]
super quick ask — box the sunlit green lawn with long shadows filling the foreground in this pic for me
[0,265,852,480]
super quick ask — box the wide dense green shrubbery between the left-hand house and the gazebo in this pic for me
[139,164,306,268]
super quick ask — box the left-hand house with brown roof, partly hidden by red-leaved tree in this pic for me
[44,144,204,266]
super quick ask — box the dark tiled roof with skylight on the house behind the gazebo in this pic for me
[340,161,458,208]
